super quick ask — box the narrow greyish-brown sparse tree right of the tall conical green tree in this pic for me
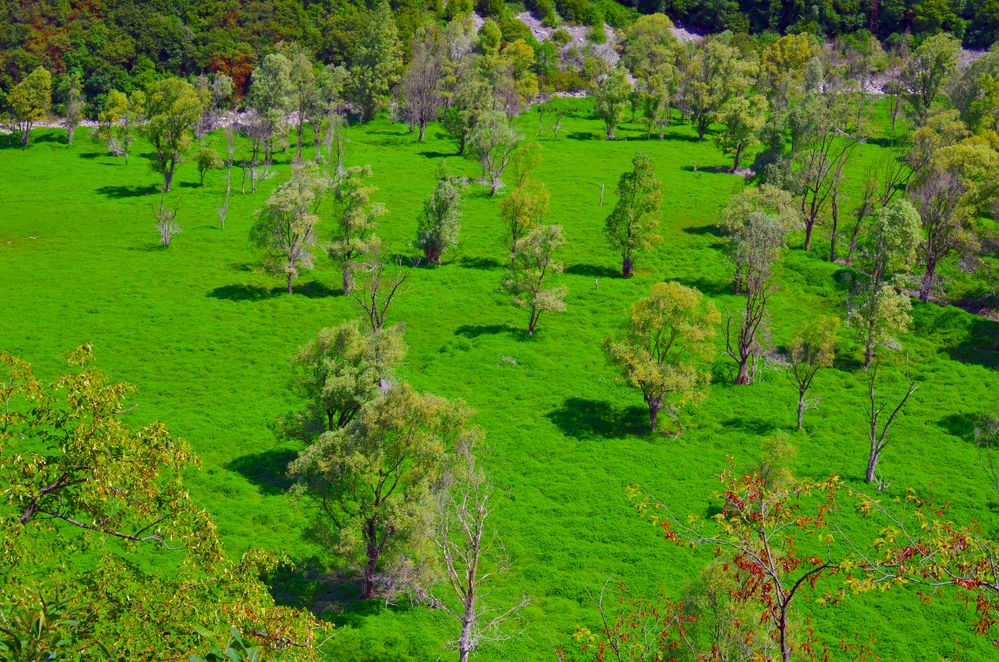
[400,25,445,142]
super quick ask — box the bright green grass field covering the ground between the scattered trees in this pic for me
[0,101,999,660]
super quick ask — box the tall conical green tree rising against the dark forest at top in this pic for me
[350,0,402,120]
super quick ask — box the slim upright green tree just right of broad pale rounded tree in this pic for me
[326,166,386,294]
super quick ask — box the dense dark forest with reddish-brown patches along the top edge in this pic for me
[0,0,999,106]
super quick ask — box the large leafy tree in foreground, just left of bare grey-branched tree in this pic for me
[288,384,471,598]
